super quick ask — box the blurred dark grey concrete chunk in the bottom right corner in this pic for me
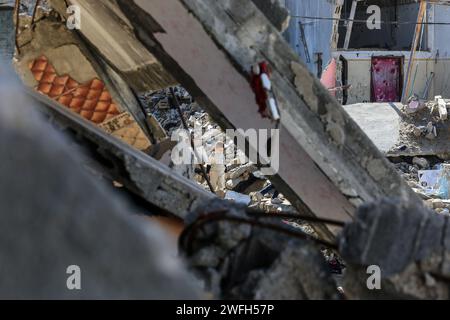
[339,199,450,300]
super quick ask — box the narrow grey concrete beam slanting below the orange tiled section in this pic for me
[25,89,214,219]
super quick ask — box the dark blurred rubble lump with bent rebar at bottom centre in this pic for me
[180,199,339,299]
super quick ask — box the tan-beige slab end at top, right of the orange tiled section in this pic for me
[50,0,176,92]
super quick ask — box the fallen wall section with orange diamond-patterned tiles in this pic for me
[15,10,166,151]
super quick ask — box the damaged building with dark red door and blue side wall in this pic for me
[286,0,450,104]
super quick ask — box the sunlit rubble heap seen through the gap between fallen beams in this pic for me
[140,86,311,216]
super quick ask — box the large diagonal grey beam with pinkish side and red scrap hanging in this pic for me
[118,0,420,240]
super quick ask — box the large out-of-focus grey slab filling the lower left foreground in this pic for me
[0,66,199,300]
